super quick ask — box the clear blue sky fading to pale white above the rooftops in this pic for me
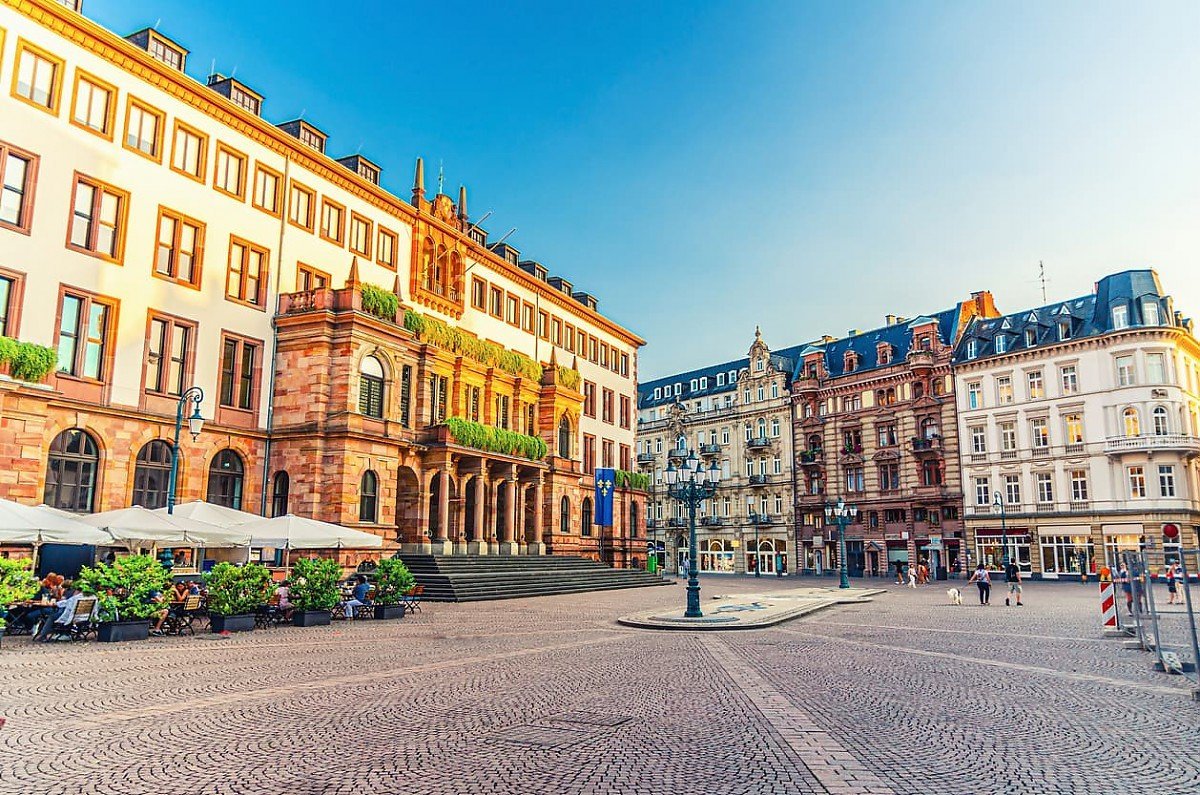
[84,0,1200,379]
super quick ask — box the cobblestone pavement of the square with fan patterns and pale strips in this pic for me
[0,578,1200,795]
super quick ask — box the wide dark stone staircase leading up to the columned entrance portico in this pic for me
[400,555,671,602]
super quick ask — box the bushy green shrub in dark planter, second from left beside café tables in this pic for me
[76,555,170,642]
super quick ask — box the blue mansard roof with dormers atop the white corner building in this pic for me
[954,269,1190,364]
